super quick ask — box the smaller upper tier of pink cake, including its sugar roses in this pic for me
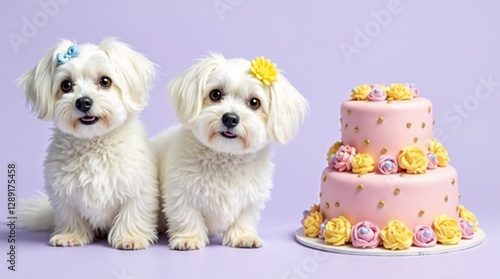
[327,84,449,174]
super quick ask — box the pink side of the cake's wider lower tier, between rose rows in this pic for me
[320,165,460,231]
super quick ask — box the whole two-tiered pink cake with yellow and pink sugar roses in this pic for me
[302,84,477,250]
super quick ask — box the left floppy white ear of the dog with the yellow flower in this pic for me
[169,53,226,124]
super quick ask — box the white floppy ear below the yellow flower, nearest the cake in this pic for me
[267,74,309,144]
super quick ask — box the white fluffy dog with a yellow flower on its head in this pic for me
[152,54,308,250]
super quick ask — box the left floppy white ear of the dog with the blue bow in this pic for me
[17,40,74,120]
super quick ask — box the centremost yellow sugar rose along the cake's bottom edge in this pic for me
[380,220,413,250]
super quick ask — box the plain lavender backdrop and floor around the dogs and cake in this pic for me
[0,0,500,279]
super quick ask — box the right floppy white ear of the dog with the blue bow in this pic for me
[99,38,157,112]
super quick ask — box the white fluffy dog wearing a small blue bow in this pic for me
[19,39,160,250]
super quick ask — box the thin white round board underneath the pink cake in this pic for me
[295,227,486,256]
